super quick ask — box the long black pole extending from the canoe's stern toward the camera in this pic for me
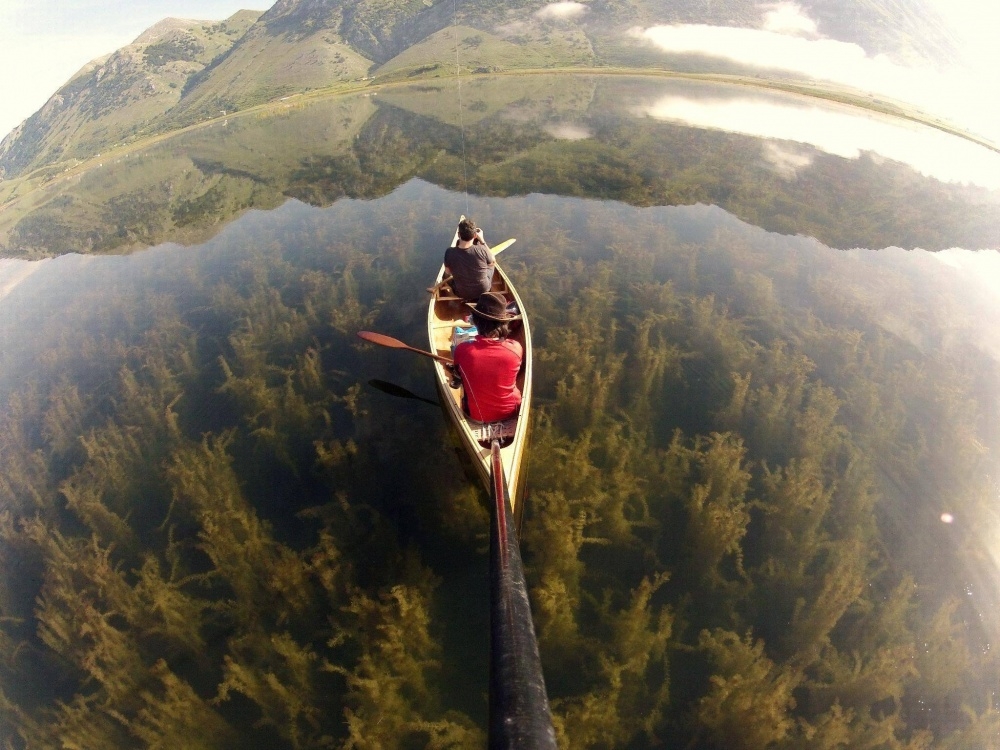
[489,440,556,750]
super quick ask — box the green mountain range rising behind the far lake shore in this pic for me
[0,0,955,180]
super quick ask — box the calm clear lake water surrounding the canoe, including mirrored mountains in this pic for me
[0,76,1000,748]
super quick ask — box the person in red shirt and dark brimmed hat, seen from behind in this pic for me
[454,292,524,422]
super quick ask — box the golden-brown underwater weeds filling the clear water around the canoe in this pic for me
[0,182,1000,750]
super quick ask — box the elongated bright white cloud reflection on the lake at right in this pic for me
[638,95,1000,189]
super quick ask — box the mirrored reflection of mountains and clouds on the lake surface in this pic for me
[0,75,1000,257]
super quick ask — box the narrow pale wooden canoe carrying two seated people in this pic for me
[427,217,531,526]
